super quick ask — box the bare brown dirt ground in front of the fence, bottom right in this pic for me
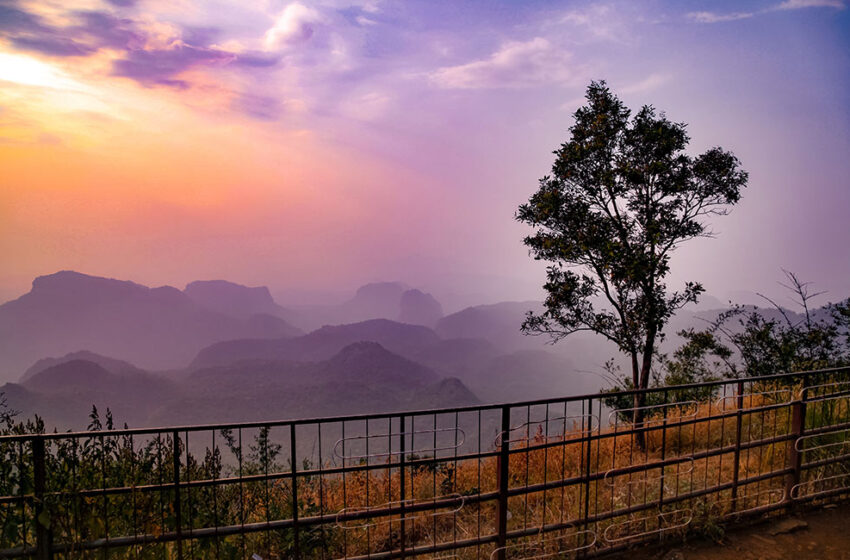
[614,505,850,560]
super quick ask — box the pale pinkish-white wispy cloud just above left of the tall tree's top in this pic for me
[431,37,575,89]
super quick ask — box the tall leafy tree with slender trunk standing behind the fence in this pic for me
[516,81,747,442]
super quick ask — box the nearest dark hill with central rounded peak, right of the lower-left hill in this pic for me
[152,342,478,423]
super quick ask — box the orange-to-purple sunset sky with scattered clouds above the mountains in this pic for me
[0,0,850,307]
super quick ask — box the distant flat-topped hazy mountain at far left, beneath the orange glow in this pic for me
[0,271,302,381]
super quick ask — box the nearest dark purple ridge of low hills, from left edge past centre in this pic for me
[0,342,480,429]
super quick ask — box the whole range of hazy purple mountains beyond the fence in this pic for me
[0,271,816,427]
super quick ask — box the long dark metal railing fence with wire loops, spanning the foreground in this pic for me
[0,368,850,560]
